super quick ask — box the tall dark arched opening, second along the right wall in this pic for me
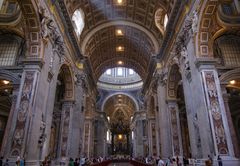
[168,64,191,158]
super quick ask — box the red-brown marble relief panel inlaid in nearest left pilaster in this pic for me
[11,71,35,156]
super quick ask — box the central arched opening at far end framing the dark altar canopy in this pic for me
[104,94,136,155]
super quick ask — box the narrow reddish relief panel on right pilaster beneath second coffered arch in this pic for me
[170,107,180,155]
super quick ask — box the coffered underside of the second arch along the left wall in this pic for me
[59,64,74,101]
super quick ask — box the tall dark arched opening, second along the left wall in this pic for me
[48,65,73,159]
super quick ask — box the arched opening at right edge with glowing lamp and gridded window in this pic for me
[213,34,240,156]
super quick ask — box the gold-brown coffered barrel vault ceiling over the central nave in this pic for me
[66,0,173,79]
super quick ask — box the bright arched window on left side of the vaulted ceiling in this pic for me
[72,9,84,36]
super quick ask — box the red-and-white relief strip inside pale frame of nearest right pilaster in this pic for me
[204,71,229,155]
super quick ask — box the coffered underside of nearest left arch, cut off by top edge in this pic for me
[17,0,41,58]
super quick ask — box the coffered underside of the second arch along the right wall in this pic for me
[167,64,182,99]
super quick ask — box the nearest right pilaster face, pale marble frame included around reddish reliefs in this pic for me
[201,69,233,156]
